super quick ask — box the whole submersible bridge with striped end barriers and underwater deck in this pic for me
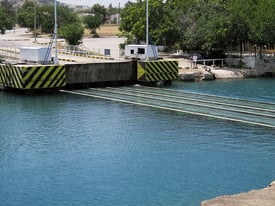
[0,46,275,128]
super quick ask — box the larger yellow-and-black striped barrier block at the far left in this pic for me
[0,64,66,90]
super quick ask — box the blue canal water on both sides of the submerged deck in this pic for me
[0,79,275,206]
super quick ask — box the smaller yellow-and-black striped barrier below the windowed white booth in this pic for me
[137,61,178,82]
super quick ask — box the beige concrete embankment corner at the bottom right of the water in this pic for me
[201,181,275,206]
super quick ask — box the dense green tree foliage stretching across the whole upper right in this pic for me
[120,0,275,52]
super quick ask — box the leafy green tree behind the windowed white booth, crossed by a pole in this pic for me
[120,0,179,45]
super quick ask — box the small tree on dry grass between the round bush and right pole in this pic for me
[84,4,107,35]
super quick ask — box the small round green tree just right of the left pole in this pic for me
[60,22,84,45]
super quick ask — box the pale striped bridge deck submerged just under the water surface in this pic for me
[62,86,275,128]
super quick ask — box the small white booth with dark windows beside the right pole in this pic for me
[124,44,158,60]
